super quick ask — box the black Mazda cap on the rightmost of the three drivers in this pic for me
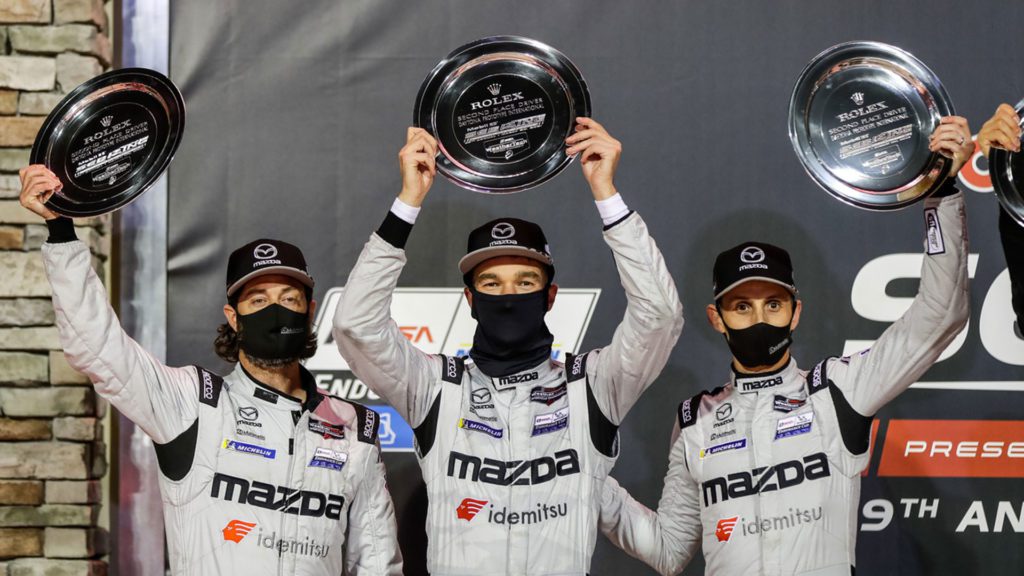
[714,242,799,300]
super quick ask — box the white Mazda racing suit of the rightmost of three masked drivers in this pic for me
[601,194,969,576]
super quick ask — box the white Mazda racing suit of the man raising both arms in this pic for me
[335,213,682,576]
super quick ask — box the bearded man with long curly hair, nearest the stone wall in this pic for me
[20,165,401,576]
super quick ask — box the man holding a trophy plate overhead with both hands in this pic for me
[334,118,682,576]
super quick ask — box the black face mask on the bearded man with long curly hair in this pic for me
[237,304,309,361]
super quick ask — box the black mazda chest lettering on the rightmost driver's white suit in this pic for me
[700,452,831,506]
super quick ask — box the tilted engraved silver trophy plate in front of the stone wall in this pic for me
[31,68,185,217]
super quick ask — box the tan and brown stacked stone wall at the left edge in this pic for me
[0,0,112,576]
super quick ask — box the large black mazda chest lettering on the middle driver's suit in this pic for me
[447,449,580,486]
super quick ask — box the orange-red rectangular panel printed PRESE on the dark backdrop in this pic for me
[879,420,1024,478]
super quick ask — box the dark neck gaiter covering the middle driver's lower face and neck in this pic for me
[469,288,554,377]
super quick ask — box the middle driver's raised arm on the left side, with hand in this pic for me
[334,128,440,426]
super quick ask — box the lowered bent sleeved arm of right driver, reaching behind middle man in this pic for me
[599,423,702,576]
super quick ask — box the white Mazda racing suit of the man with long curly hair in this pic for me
[43,236,401,576]
